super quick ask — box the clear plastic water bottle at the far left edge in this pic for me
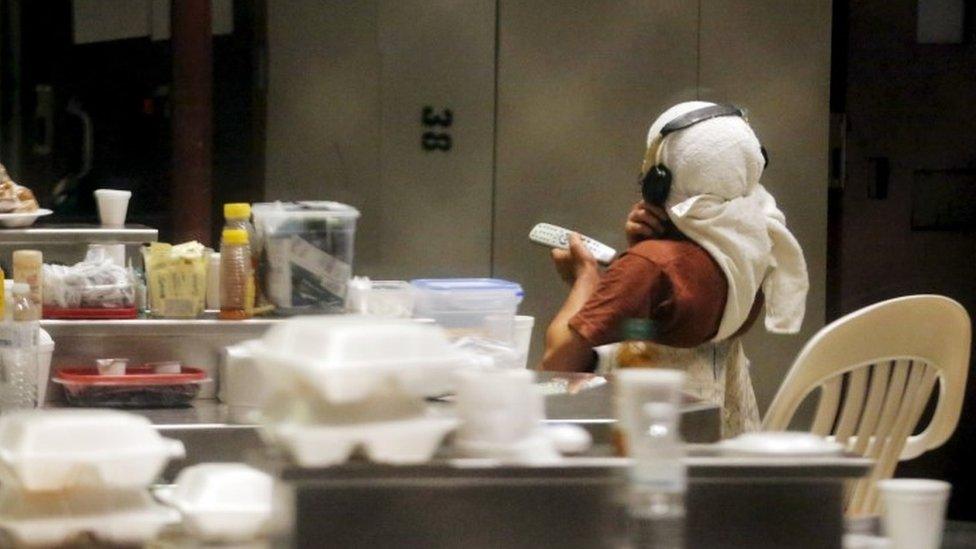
[0,283,39,413]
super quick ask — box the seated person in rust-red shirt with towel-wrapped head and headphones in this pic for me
[542,101,809,437]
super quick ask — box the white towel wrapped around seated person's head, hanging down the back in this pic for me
[648,101,809,341]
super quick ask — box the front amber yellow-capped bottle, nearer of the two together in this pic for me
[220,229,254,320]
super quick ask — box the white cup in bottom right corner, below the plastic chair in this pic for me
[878,478,952,549]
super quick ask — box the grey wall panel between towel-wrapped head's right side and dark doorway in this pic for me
[699,0,830,409]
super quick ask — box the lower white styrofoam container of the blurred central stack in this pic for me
[273,416,458,467]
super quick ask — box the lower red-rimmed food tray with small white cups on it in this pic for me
[54,366,209,408]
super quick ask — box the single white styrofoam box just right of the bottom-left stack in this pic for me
[166,463,274,542]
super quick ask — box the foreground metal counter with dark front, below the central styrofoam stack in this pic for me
[268,454,871,549]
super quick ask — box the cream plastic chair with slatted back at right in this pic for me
[763,295,972,516]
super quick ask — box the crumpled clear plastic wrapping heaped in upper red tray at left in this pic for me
[43,249,136,309]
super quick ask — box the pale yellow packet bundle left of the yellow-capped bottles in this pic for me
[143,242,211,318]
